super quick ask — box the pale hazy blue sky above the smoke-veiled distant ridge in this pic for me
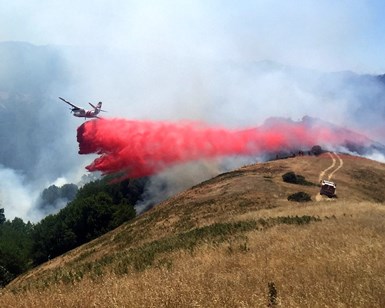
[0,0,385,73]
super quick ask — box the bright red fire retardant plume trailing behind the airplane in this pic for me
[77,119,364,178]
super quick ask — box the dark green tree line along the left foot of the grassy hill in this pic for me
[0,178,146,286]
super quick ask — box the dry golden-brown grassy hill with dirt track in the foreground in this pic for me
[0,153,385,307]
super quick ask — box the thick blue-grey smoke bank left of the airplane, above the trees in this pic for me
[0,42,84,221]
